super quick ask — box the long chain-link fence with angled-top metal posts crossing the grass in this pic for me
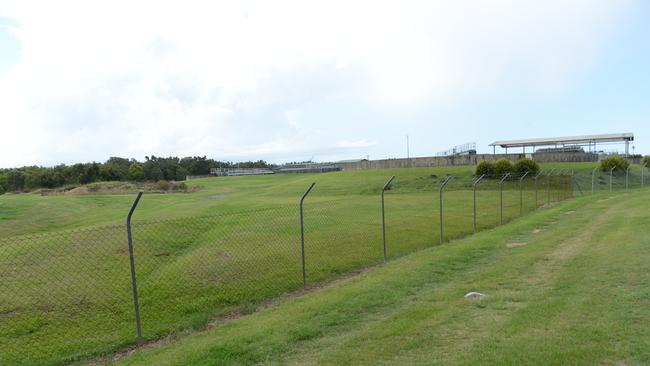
[0,172,641,365]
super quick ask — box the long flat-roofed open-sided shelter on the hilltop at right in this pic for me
[490,132,634,156]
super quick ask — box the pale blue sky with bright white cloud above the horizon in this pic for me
[0,0,650,168]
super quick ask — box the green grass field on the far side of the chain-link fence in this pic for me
[0,164,644,364]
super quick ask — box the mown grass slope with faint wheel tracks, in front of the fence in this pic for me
[116,190,650,365]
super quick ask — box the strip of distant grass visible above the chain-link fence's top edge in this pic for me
[0,163,595,236]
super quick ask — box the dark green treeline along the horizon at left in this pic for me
[0,155,271,194]
